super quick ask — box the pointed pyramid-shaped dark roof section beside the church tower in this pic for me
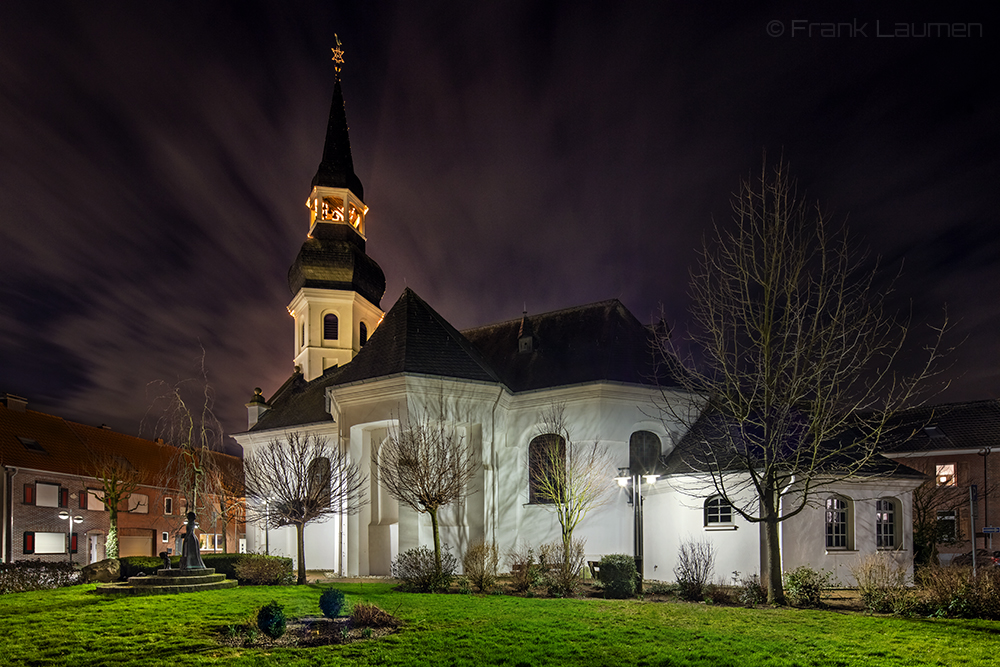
[332,287,499,385]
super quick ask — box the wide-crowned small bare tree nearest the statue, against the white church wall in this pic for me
[243,433,368,584]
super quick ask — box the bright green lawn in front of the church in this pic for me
[0,583,1000,667]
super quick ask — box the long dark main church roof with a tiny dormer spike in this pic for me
[462,299,675,392]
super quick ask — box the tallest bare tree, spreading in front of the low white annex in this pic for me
[661,163,947,603]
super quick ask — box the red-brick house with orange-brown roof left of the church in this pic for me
[0,394,245,564]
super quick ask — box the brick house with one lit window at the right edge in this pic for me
[883,399,1000,565]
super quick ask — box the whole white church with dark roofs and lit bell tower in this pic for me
[235,62,923,583]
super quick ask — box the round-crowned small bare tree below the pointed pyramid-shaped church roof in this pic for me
[372,407,480,573]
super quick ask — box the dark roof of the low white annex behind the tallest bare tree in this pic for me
[662,414,926,479]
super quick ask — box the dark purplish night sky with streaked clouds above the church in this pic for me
[0,0,1000,446]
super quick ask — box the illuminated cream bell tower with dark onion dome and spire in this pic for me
[288,39,385,380]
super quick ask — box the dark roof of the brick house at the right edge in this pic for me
[886,399,1000,452]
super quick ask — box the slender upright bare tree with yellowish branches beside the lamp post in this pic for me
[529,405,615,568]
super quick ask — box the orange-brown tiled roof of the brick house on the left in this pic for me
[0,396,239,486]
